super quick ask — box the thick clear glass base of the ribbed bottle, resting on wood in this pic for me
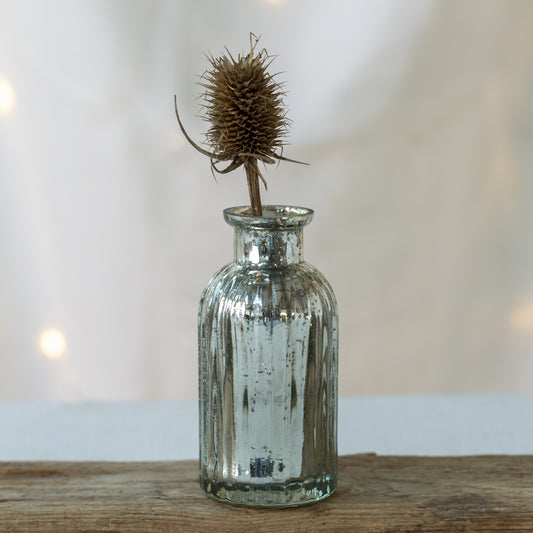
[200,475,337,508]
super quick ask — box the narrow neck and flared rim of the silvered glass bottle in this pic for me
[224,206,313,267]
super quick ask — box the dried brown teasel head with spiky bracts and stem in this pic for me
[174,34,300,216]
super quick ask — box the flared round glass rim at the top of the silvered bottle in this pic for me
[224,205,314,229]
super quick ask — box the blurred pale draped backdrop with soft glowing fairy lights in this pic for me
[0,0,533,401]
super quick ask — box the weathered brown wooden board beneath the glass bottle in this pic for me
[0,454,533,533]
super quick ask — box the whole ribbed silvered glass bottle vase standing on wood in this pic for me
[198,206,338,507]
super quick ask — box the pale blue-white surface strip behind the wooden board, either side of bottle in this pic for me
[0,395,533,461]
